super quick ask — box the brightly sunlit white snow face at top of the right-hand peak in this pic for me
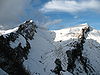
[54,23,92,41]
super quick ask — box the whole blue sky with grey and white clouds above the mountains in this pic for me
[0,0,100,30]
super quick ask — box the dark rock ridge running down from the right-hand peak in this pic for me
[66,27,95,75]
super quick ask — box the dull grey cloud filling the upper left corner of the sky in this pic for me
[0,0,31,24]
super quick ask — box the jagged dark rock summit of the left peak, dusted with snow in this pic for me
[17,21,36,40]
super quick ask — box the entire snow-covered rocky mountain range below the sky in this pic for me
[0,21,100,75]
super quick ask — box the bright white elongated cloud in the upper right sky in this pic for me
[41,0,100,13]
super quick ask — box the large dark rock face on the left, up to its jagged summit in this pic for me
[0,21,36,75]
